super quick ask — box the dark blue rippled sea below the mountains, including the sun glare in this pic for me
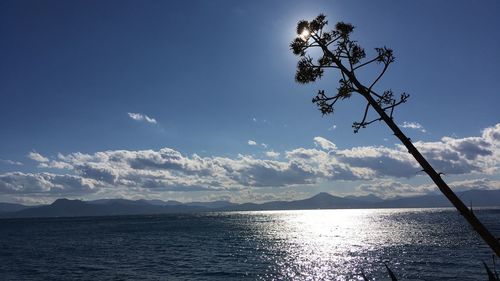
[0,209,500,280]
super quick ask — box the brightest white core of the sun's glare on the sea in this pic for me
[256,210,384,280]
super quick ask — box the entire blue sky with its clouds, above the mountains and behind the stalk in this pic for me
[0,0,500,204]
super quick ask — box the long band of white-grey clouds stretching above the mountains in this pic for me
[0,124,500,197]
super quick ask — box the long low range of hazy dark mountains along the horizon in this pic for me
[0,190,500,217]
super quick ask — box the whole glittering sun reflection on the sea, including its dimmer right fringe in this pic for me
[238,209,484,280]
